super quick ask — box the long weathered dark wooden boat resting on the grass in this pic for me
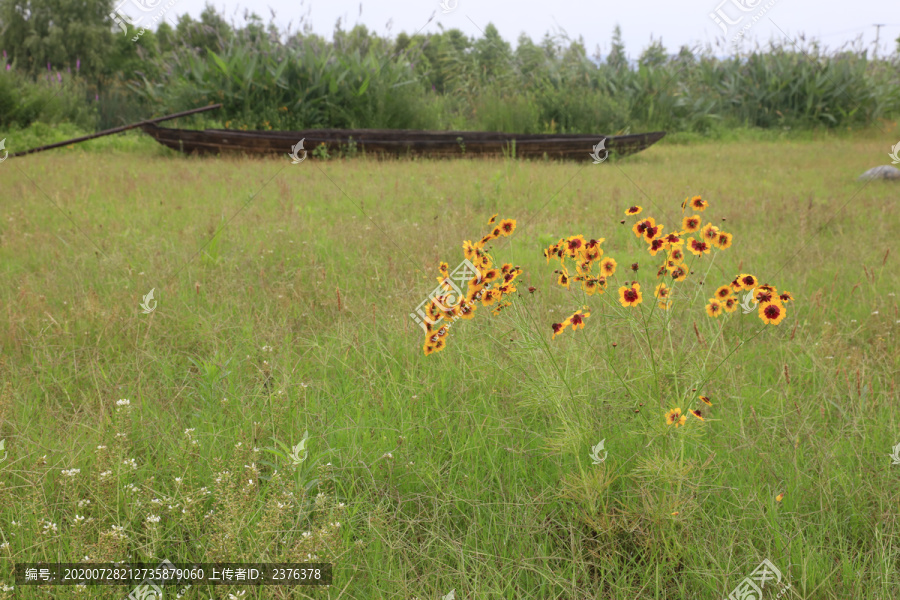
[141,123,666,160]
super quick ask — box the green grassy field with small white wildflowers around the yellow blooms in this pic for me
[0,130,900,600]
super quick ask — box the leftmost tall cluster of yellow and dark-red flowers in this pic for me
[423,215,522,356]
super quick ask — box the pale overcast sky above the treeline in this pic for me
[125,0,900,58]
